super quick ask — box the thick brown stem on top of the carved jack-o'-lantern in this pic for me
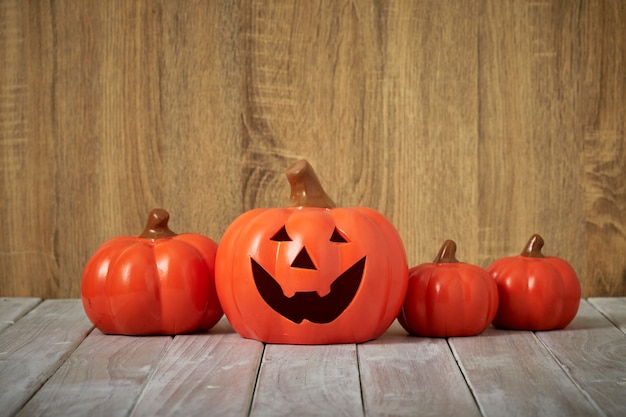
[286,159,336,208]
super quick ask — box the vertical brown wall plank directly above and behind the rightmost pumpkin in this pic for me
[476,1,584,272]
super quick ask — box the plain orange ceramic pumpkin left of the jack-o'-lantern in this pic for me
[81,209,223,335]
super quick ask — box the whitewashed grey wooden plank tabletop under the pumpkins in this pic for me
[0,298,626,417]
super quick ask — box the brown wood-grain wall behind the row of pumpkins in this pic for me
[0,0,626,297]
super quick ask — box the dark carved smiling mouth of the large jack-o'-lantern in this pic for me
[250,257,365,324]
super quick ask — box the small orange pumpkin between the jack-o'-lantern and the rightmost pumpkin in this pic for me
[398,240,498,337]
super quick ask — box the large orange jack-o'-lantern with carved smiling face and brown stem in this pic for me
[216,160,408,344]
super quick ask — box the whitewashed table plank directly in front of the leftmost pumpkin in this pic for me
[18,330,172,417]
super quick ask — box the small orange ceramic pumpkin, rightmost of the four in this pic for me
[487,234,581,331]
